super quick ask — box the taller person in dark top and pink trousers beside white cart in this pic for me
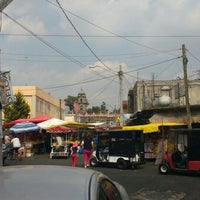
[81,133,94,168]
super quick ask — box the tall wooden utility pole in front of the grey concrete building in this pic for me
[182,44,192,128]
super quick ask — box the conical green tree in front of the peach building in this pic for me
[3,92,30,122]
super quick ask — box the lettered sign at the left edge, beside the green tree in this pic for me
[0,71,15,108]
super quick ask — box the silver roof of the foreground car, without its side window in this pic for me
[0,165,95,200]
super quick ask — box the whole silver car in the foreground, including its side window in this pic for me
[0,165,129,200]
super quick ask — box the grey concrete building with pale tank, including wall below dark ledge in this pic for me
[128,79,200,123]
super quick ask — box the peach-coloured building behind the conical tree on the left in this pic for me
[12,86,65,119]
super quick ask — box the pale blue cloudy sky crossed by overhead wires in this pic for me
[0,0,200,110]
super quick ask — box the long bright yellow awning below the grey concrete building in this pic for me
[122,122,185,134]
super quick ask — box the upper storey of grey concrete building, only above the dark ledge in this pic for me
[128,79,200,113]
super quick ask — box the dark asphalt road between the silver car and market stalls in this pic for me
[5,154,200,200]
